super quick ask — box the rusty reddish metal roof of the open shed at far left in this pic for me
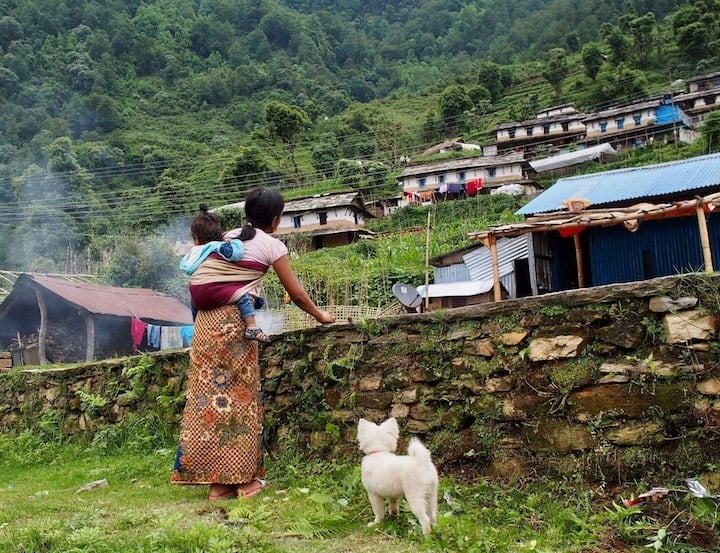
[0,274,193,326]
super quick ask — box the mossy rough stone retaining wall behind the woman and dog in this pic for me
[0,275,720,483]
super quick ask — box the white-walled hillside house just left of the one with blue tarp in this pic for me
[494,104,585,153]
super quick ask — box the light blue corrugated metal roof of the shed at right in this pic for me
[515,154,720,215]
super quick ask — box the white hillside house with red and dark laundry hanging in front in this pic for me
[398,153,535,205]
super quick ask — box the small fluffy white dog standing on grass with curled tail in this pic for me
[357,418,438,535]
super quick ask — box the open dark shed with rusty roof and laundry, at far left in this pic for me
[0,274,192,365]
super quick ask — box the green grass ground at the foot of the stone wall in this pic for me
[0,427,719,553]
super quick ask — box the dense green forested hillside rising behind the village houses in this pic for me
[0,0,720,302]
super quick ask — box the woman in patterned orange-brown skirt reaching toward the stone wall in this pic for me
[172,189,335,501]
